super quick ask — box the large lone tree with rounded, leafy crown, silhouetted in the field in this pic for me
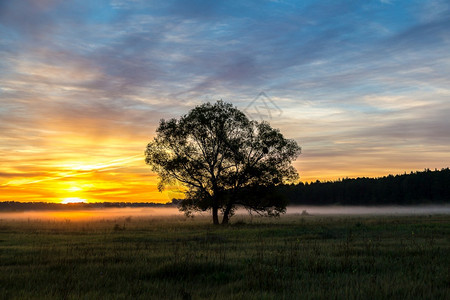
[145,100,301,224]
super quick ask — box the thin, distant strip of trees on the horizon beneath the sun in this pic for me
[0,201,176,212]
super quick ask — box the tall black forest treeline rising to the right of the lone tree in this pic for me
[278,168,450,205]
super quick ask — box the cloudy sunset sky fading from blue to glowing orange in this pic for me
[0,0,450,202]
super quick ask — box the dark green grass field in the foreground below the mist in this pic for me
[0,215,450,299]
